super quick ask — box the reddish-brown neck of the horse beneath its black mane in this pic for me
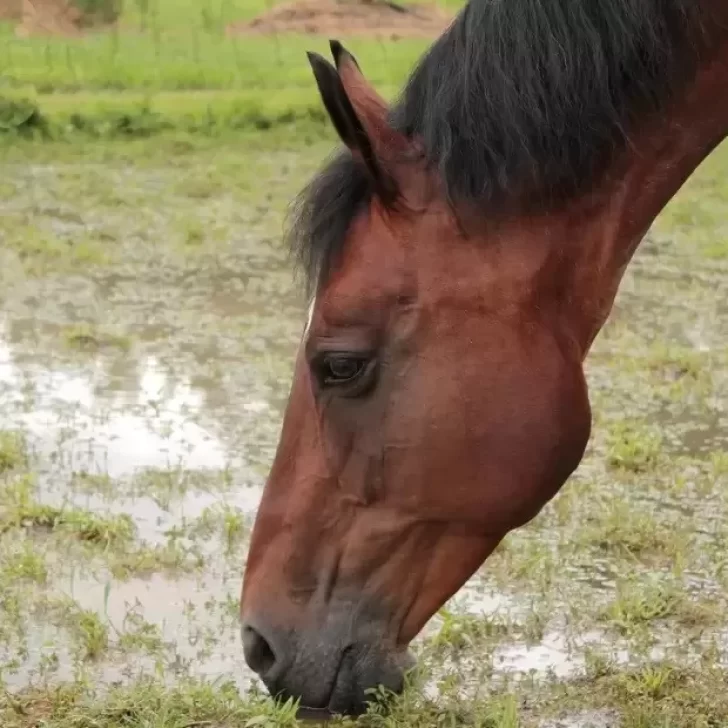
[555,31,728,357]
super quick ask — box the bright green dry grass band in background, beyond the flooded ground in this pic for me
[0,0,458,138]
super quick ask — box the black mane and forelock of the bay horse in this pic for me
[289,0,712,284]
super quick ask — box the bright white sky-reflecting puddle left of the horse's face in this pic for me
[0,324,229,478]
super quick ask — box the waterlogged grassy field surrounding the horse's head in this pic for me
[0,0,728,728]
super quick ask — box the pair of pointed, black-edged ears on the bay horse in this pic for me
[308,41,399,203]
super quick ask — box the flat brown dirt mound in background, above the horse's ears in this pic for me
[228,0,454,39]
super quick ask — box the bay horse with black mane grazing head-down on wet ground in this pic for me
[241,0,728,714]
